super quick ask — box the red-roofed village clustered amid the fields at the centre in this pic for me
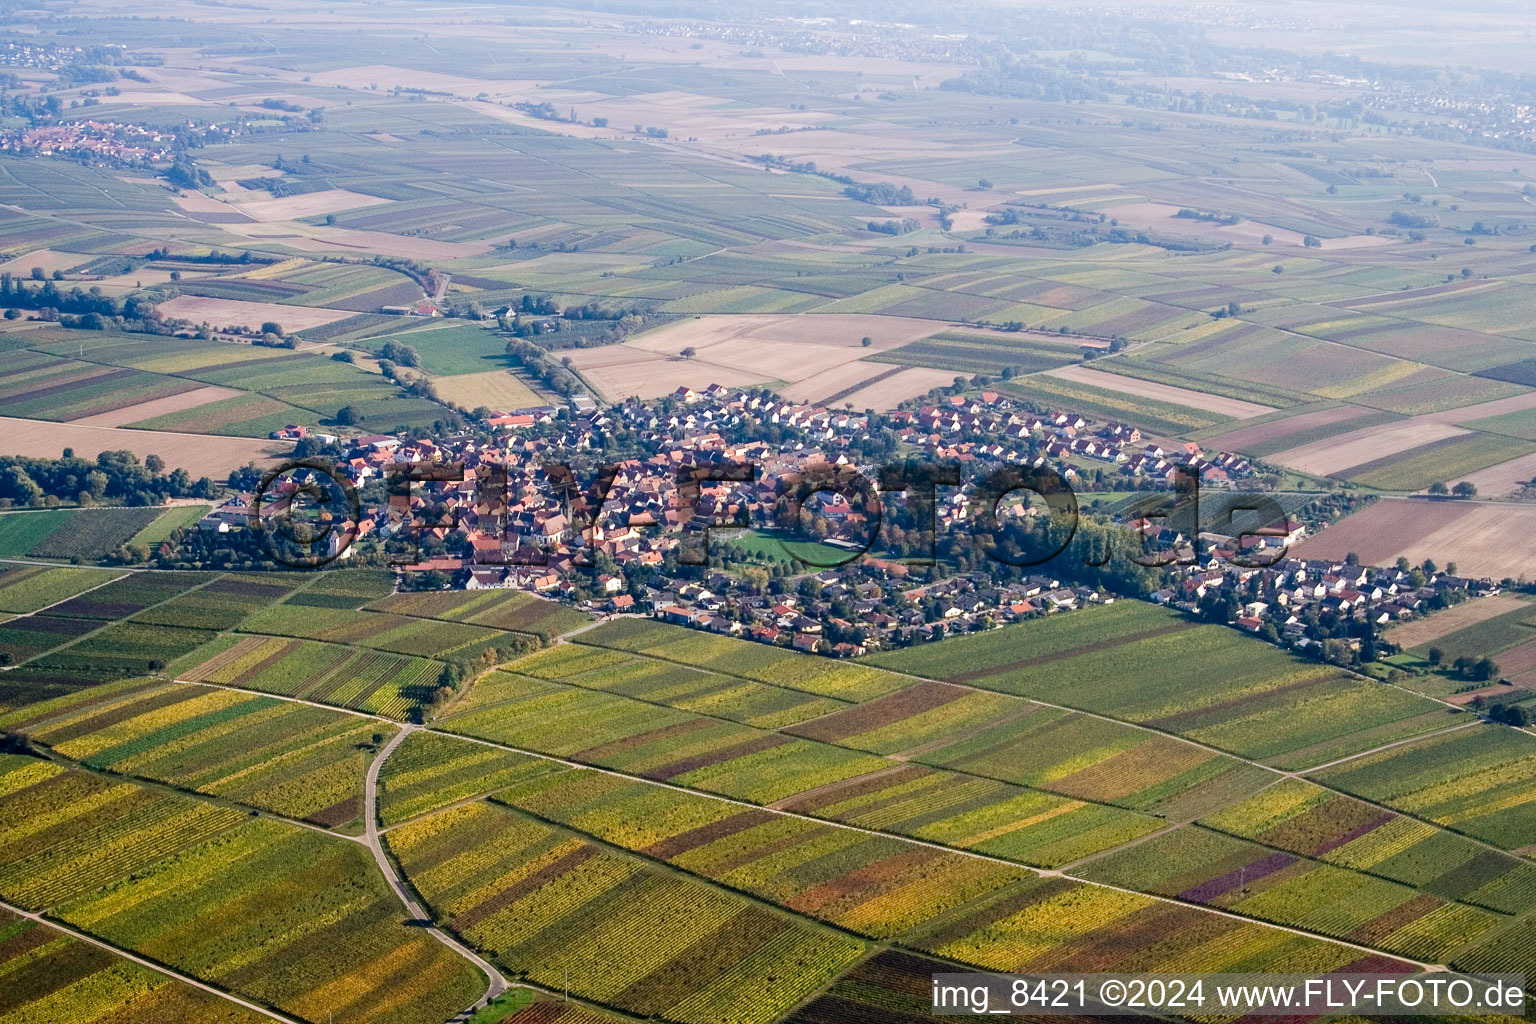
[201,385,1498,662]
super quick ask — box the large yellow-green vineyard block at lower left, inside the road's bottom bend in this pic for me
[0,755,482,1024]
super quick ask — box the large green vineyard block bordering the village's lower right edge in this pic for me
[868,602,1455,769]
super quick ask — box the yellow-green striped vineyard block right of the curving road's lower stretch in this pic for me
[387,803,865,1024]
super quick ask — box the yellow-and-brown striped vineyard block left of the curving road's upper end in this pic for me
[0,683,389,827]
